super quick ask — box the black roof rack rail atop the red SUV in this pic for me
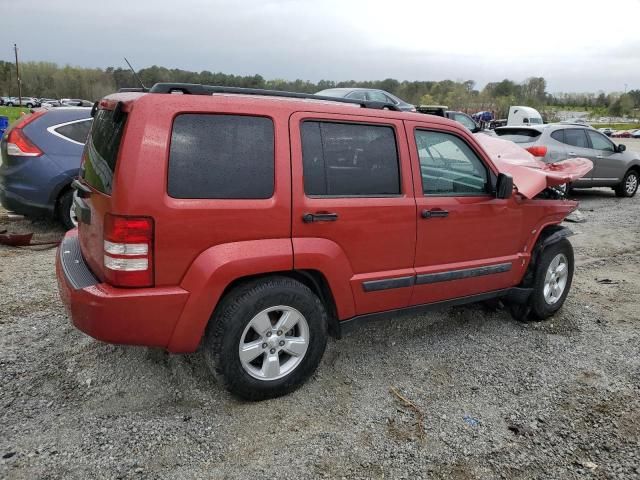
[148,83,400,111]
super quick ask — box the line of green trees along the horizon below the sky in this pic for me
[0,61,640,117]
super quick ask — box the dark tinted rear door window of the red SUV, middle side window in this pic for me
[301,121,400,196]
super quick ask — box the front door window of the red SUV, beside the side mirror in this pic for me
[415,130,488,195]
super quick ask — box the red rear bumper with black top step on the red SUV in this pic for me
[56,230,189,347]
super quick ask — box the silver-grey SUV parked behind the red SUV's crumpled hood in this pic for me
[495,124,640,197]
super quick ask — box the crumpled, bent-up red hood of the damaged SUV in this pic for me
[475,135,593,198]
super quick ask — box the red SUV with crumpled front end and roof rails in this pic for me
[57,84,592,400]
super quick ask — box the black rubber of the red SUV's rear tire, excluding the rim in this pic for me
[204,276,327,401]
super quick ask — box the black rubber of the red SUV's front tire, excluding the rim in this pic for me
[529,238,574,320]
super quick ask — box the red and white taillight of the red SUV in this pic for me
[104,213,153,287]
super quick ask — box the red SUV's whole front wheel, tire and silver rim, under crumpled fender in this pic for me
[530,238,574,320]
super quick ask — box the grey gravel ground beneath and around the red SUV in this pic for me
[0,189,640,479]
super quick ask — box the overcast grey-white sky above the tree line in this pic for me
[0,0,640,92]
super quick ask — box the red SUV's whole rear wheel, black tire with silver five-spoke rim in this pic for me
[204,277,327,400]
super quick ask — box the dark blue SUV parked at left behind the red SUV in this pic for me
[0,108,92,228]
